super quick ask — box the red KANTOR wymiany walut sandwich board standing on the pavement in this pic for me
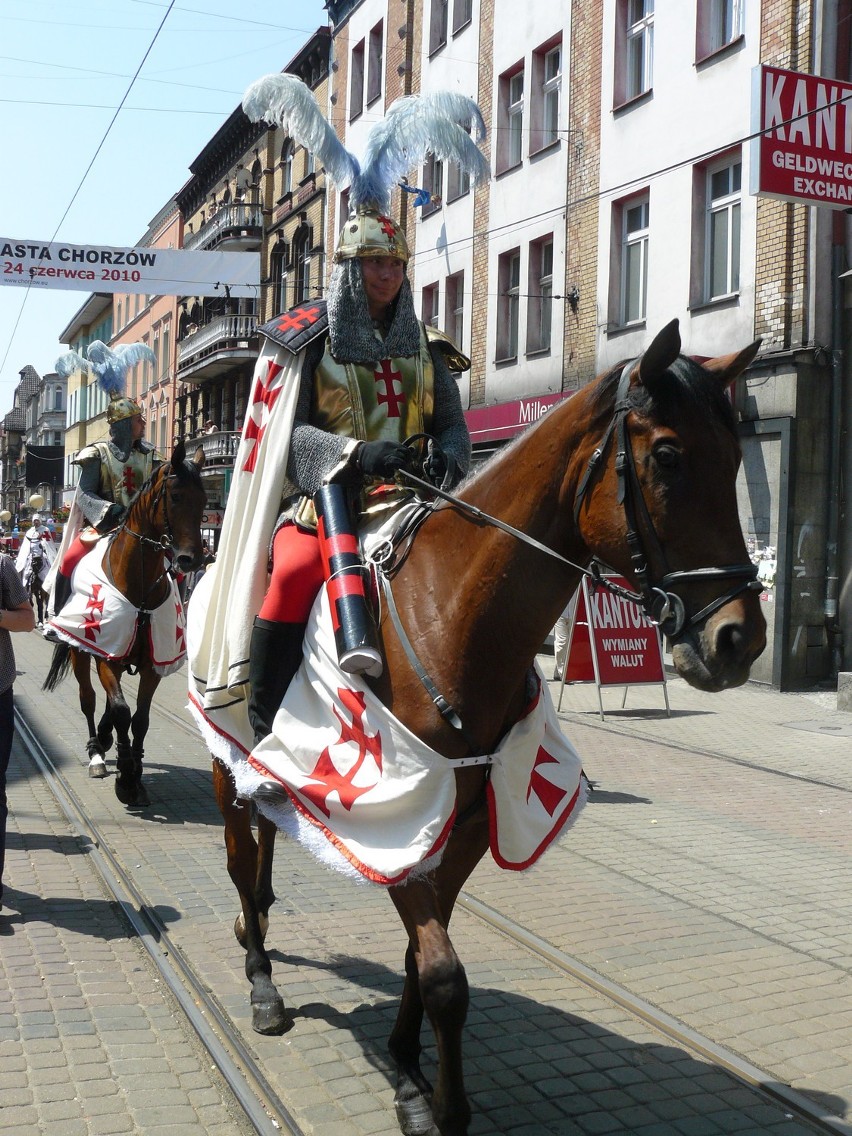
[558,574,671,719]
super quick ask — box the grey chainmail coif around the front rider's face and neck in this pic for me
[328,257,420,362]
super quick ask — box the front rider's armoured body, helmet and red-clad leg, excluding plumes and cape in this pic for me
[249,207,470,741]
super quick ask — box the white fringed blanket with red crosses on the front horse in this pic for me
[190,574,585,885]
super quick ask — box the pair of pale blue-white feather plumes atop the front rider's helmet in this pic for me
[243,74,490,212]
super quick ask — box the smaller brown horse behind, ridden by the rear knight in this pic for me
[43,442,207,805]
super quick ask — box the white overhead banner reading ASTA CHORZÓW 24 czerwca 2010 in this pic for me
[0,236,260,298]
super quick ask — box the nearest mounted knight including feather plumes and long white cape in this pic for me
[189,74,488,752]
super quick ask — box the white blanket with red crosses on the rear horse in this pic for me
[48,540,186,675]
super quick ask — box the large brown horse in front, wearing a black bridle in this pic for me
[214,321,766,1136]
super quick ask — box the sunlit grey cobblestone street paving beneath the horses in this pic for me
[0,635,852,1136]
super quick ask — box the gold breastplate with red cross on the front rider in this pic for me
[310,327,435,442]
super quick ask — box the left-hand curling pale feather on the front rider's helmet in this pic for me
[243,74,359,189]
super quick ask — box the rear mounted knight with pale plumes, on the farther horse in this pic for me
[51,340,161,615]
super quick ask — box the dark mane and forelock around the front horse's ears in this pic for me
[591,356,737,437]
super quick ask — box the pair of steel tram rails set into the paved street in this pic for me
[17,672,852,1136]
